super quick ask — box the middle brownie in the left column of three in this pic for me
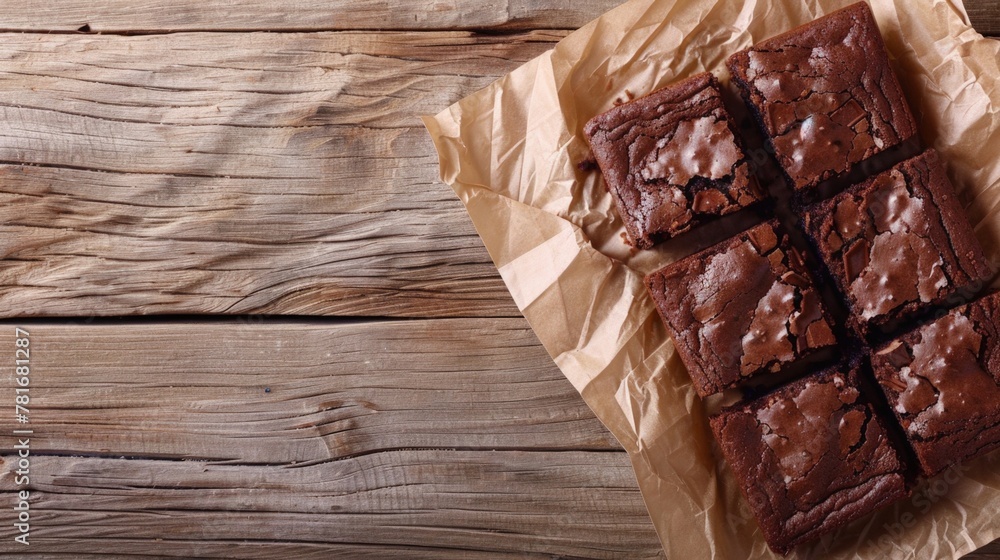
[646,220,837,397]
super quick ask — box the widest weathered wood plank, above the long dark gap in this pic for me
[0,32,565,316]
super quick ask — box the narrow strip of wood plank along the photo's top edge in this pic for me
[0,0,622,33]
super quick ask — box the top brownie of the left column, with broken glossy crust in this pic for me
[583,72,762,249]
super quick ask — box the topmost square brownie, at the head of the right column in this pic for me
[728,2,917,198]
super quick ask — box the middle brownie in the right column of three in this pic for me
[803,150,993,336]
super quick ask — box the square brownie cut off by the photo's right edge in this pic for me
[872,293,1000,476]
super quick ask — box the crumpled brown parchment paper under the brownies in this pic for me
[424,0,1000,559]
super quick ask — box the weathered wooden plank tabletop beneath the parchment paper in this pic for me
[0,0,1000,559]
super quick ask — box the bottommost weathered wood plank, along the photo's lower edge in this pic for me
[0,450,662,558]
